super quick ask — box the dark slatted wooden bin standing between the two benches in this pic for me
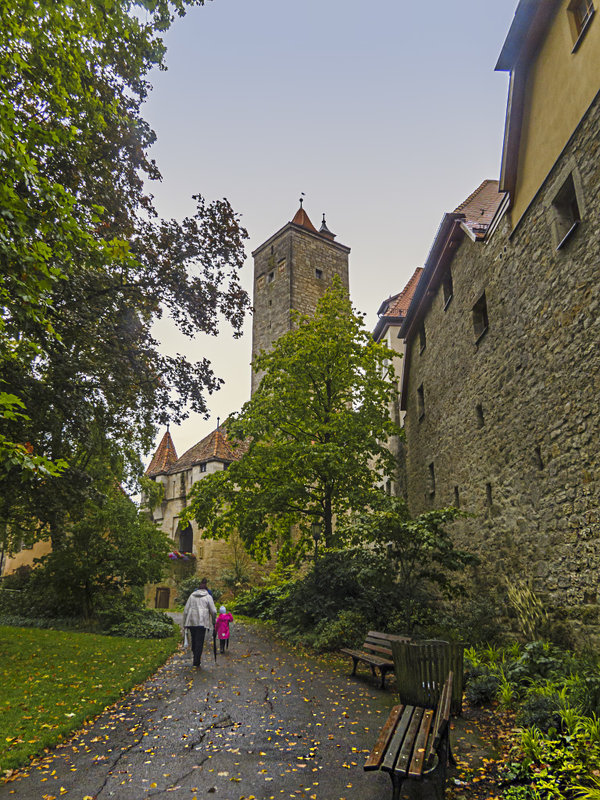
[392,640,464,714]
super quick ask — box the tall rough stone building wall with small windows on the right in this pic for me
[405,92,600,626]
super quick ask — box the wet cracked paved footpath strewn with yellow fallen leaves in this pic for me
[0,624,394,800]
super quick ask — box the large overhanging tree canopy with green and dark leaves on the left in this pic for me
[0,0,248,546]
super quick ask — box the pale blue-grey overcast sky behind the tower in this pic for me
[142,0,517,462]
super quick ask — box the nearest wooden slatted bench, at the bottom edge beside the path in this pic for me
[364,672,454,800]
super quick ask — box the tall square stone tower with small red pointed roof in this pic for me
[252,200,350,393]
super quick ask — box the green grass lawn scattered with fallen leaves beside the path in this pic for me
[0,626,178,773]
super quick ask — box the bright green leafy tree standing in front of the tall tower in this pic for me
[187,281,404,556]
